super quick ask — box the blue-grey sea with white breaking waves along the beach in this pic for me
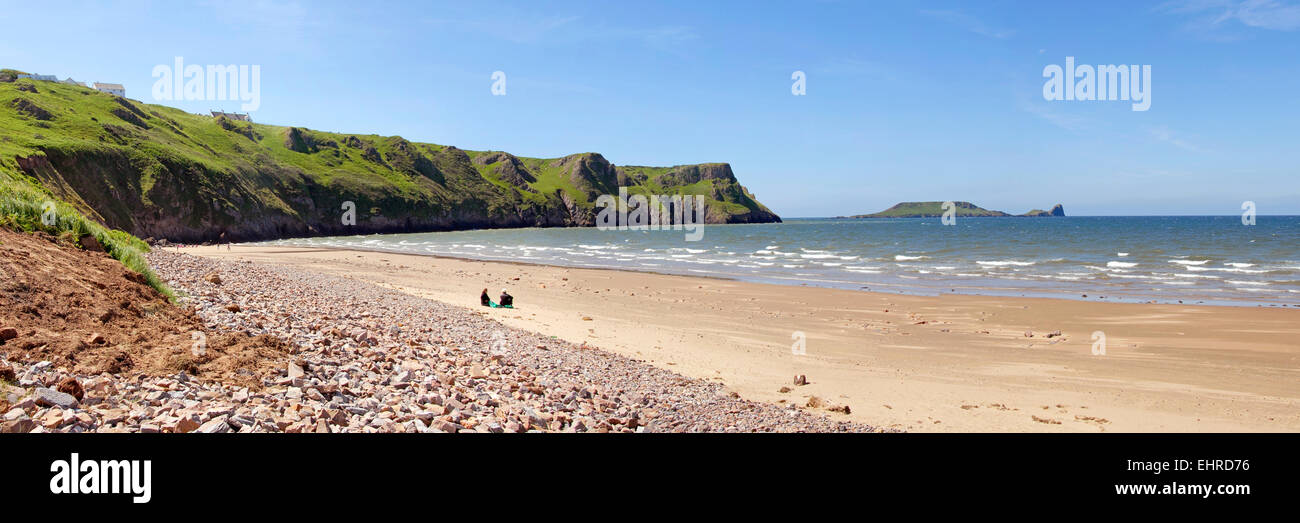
[250,216,1300,307]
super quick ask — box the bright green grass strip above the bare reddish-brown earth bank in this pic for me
[0,172,176,301]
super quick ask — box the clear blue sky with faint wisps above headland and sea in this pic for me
[0,0,1300,217]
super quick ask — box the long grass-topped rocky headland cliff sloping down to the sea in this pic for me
[0,81,780,242]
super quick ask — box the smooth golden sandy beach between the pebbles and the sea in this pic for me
[183,245,1300,432]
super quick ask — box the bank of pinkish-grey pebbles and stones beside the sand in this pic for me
[0,250,874,432]
